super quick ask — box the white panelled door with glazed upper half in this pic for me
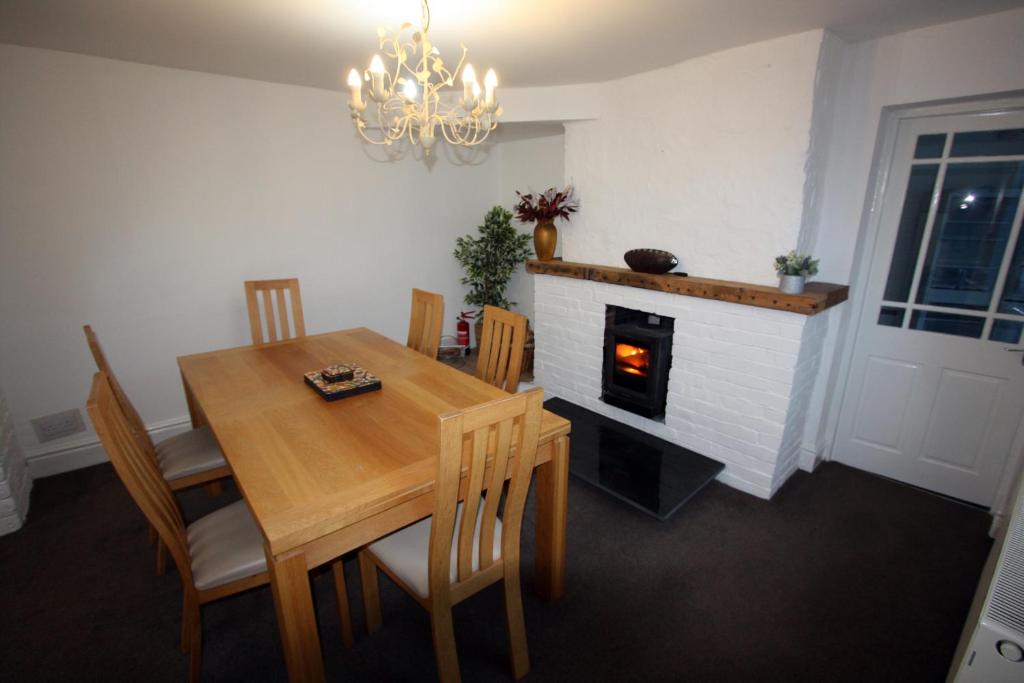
[833,110,1024,506]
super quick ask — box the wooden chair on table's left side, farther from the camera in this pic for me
[82,325,231,574]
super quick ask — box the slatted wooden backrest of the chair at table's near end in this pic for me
[428,388,544,598]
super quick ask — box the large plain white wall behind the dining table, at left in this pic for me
[0,45,499,471]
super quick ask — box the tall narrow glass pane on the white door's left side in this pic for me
[885,164,939,301]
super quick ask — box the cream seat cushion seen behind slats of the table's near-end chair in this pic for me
[370,499,502,598]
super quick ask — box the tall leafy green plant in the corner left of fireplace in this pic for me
[455,206,529,344]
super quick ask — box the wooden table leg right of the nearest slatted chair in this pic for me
[536,436,569,600]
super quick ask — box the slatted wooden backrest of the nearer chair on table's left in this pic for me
[87,372,195,588]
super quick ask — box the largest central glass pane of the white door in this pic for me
[918,162,1024,310]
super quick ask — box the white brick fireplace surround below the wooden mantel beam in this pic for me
[534,274,833,499]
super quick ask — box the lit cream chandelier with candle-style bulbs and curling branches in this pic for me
[348,0,502,155]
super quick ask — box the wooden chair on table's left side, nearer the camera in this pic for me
[88,372,351,681]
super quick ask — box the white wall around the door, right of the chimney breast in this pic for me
[808,9,1024,466]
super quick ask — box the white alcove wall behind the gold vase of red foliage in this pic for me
[498,126,565,327]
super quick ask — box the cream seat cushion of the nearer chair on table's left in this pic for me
[186,501,266,591]
